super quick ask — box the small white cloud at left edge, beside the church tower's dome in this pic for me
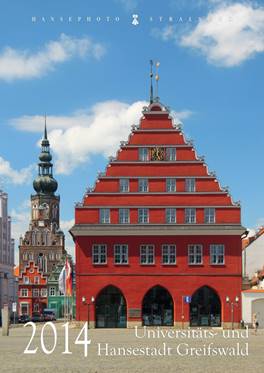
[0,157,35,185]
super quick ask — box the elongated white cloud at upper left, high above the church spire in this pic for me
[0,34,105,81]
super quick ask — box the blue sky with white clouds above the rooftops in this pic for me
[0,0,264,264]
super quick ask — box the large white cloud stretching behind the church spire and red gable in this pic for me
[10,101,190,174]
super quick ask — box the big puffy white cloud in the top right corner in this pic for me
[182,3,264,67]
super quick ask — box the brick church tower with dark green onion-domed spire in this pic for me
[19,121,66,276]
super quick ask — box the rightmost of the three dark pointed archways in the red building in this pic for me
[190,286,221,326]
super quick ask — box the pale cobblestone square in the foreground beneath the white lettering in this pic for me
[0,323,264,373]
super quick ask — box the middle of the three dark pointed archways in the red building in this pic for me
[142,286,174,326]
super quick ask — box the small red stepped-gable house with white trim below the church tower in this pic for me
[18,261,47,317]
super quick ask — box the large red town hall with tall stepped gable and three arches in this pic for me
[71,99,244,327]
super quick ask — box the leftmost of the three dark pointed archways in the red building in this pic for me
[95,285,127,328]
